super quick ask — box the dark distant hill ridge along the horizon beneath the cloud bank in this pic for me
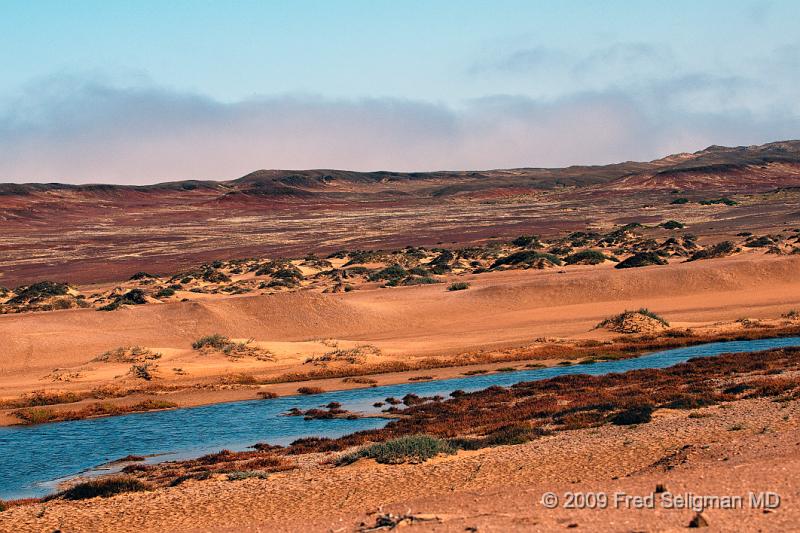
[0,141,800,201]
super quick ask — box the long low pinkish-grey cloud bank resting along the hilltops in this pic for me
[0,77,800,183]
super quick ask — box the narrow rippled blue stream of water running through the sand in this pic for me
[0,337,800,499]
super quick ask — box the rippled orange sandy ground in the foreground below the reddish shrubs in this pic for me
[0,392,800,532]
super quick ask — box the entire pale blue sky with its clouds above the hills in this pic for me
[0,0,800,184]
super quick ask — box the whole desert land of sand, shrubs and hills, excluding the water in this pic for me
[0,142,800,531]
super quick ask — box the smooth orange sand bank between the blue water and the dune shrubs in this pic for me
[0,253,800,424]
